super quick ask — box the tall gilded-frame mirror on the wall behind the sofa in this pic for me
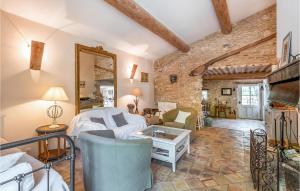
[75,44,117,114]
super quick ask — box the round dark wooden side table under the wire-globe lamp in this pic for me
[35,124,68,162]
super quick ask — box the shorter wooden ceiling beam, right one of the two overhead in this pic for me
[212,0,232,34]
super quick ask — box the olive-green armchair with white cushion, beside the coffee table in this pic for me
[163,107,198,140]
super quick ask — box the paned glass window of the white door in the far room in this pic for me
[242,86,259,106]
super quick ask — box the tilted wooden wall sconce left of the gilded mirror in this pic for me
[30,40,45,70]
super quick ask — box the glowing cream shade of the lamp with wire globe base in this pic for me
[42,87,69,101]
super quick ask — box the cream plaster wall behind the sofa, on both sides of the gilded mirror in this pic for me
[1,12,154,154]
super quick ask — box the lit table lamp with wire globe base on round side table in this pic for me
[42,87,69,128]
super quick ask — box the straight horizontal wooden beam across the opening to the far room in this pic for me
[203,72,270,80]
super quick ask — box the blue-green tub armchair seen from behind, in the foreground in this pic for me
[79,130,152,191]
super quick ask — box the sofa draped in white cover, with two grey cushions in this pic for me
[68,107,147,139]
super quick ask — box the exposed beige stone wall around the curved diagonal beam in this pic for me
[154,6,276,110]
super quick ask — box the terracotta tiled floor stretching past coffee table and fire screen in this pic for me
[56,125,262,191]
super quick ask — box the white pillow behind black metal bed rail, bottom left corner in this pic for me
[0,162,34,191]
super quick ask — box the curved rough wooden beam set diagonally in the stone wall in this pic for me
[190,33,276,76]
